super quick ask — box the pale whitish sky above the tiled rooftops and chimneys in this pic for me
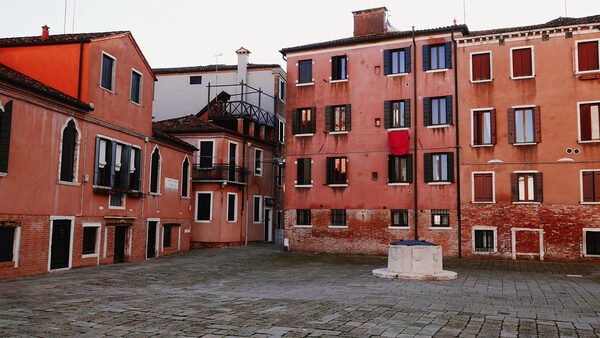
[0,0,600,68]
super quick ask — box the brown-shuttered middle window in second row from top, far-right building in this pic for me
[508,107,542,144]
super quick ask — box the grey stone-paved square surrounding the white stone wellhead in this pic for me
[0,246,600,337]
